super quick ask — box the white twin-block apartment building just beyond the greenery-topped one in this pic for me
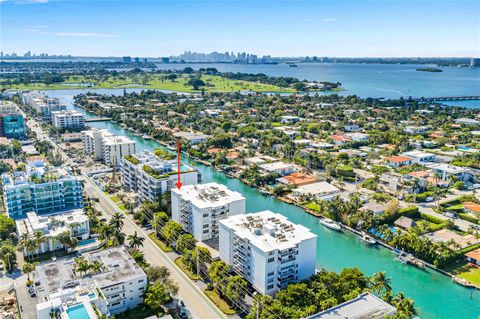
[83,129,135,167]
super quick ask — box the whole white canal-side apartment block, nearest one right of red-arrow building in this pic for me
[219,210,317,295]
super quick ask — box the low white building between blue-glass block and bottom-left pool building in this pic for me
[16,209,90,256]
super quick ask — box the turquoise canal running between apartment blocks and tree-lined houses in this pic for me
[48,89,480,319]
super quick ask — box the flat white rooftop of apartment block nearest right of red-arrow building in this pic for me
[220,210,317,252]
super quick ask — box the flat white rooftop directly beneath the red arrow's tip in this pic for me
[172,182,245,209]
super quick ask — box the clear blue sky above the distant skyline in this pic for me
[0,0,480,57]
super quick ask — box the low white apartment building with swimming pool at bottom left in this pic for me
[34,246,147,319]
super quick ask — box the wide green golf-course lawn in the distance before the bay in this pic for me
[0,74,295,92]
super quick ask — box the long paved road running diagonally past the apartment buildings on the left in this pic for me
[27,113,227,319]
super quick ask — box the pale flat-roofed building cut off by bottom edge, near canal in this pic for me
[305,292,397,319]
